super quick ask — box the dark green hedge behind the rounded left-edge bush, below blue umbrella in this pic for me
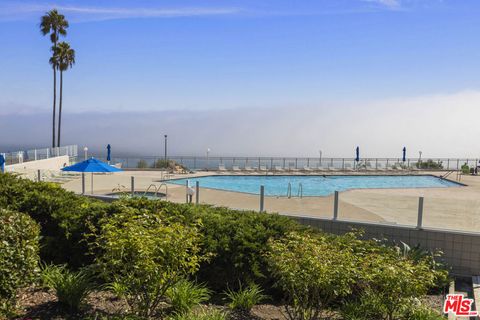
[0,174,109,267]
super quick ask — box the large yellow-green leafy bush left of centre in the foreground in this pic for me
[96,208,202,317]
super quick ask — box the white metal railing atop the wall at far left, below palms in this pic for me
[0,145,78,165]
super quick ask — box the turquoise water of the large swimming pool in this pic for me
[170,176,461,196]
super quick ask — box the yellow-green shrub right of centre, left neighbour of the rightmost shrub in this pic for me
[267,233,355,320]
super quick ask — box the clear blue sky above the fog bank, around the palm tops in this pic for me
[0,0,480,112]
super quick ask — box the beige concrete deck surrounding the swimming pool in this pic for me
[63,170,480,232]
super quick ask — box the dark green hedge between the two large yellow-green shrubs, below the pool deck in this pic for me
[111,198,305,293]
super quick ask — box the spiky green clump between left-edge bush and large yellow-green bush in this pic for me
[41,265,95,312]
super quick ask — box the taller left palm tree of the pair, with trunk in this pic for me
[40,9,68,148]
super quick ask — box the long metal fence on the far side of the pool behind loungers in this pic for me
[90,155,479,171]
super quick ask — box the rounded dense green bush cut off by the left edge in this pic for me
[0,209,40,316]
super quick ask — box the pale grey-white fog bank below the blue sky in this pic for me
[0,91,480,157]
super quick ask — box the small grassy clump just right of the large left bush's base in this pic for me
[166,279,210,314]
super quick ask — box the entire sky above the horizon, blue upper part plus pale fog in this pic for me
[0,0,480,156]
